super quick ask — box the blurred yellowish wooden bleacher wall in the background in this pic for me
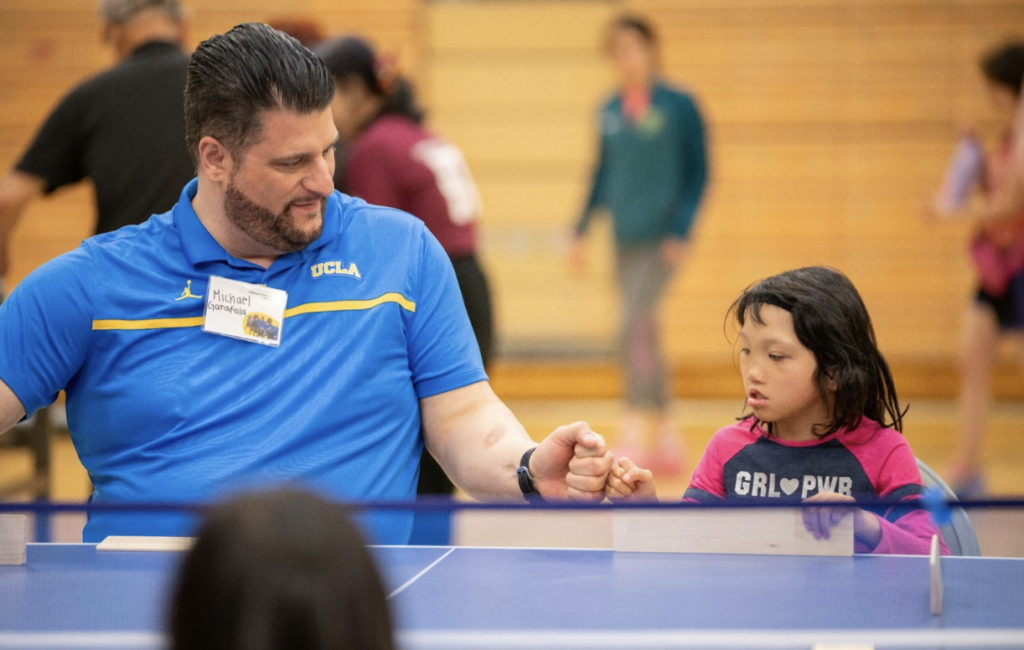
[0,0,1024,398]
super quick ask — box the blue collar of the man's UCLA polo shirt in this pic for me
[174,178,341,268]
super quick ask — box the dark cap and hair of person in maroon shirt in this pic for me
[314,36,426,124]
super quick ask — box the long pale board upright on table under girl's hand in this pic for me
[612,508,853,556]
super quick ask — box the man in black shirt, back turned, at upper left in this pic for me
[0,0,195,276]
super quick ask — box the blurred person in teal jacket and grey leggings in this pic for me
[572,15,708,473]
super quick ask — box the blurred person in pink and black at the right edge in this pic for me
[927,41,1024,499]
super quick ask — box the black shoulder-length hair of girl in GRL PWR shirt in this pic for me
[727,266,906,437]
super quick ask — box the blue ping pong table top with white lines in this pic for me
[0,545,1024,650]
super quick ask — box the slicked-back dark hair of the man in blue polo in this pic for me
[185,23,334,164]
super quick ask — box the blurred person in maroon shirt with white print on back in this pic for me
[315,37,494,494]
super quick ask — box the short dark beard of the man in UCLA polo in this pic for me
[224,180,327,253]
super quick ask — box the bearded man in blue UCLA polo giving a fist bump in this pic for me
[0,24,612,544]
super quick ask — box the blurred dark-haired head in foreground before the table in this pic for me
[170,490,394,650]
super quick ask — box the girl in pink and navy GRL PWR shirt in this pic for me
[606,266,948,555]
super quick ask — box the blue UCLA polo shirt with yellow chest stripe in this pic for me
[0,180,486,544]
